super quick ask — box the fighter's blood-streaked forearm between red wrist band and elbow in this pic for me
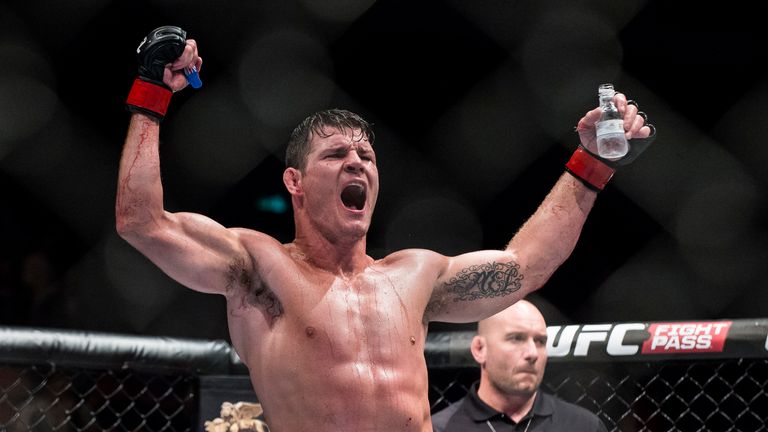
[115,114,163,233]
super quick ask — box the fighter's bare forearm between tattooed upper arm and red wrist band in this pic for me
[507,173,597,289]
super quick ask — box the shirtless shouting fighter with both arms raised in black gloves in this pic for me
[116,27,651,432]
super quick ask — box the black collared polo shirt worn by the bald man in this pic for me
[432,382,606,432]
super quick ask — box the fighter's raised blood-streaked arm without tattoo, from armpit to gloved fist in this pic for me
[115,27,250,294]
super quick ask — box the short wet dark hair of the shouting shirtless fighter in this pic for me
[285,108,374,171]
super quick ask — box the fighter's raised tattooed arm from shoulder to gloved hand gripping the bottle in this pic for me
[426,90,655,322]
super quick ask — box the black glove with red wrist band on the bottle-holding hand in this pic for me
[565,106,656,192]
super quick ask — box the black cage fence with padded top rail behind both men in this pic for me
[0,320,768,432]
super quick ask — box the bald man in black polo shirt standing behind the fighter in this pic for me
[432,300,606,432]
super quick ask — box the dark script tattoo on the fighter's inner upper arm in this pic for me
[444,261,523,302]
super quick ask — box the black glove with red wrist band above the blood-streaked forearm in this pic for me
[126,26,187,121]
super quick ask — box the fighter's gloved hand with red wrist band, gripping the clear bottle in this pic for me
[565,93,656,192]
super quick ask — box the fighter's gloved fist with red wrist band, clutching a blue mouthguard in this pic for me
[126,26,203,121]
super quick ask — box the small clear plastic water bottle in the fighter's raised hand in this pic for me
[597,84,629,160]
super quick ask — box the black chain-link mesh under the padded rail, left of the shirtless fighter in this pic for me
[0,362,197,432]
